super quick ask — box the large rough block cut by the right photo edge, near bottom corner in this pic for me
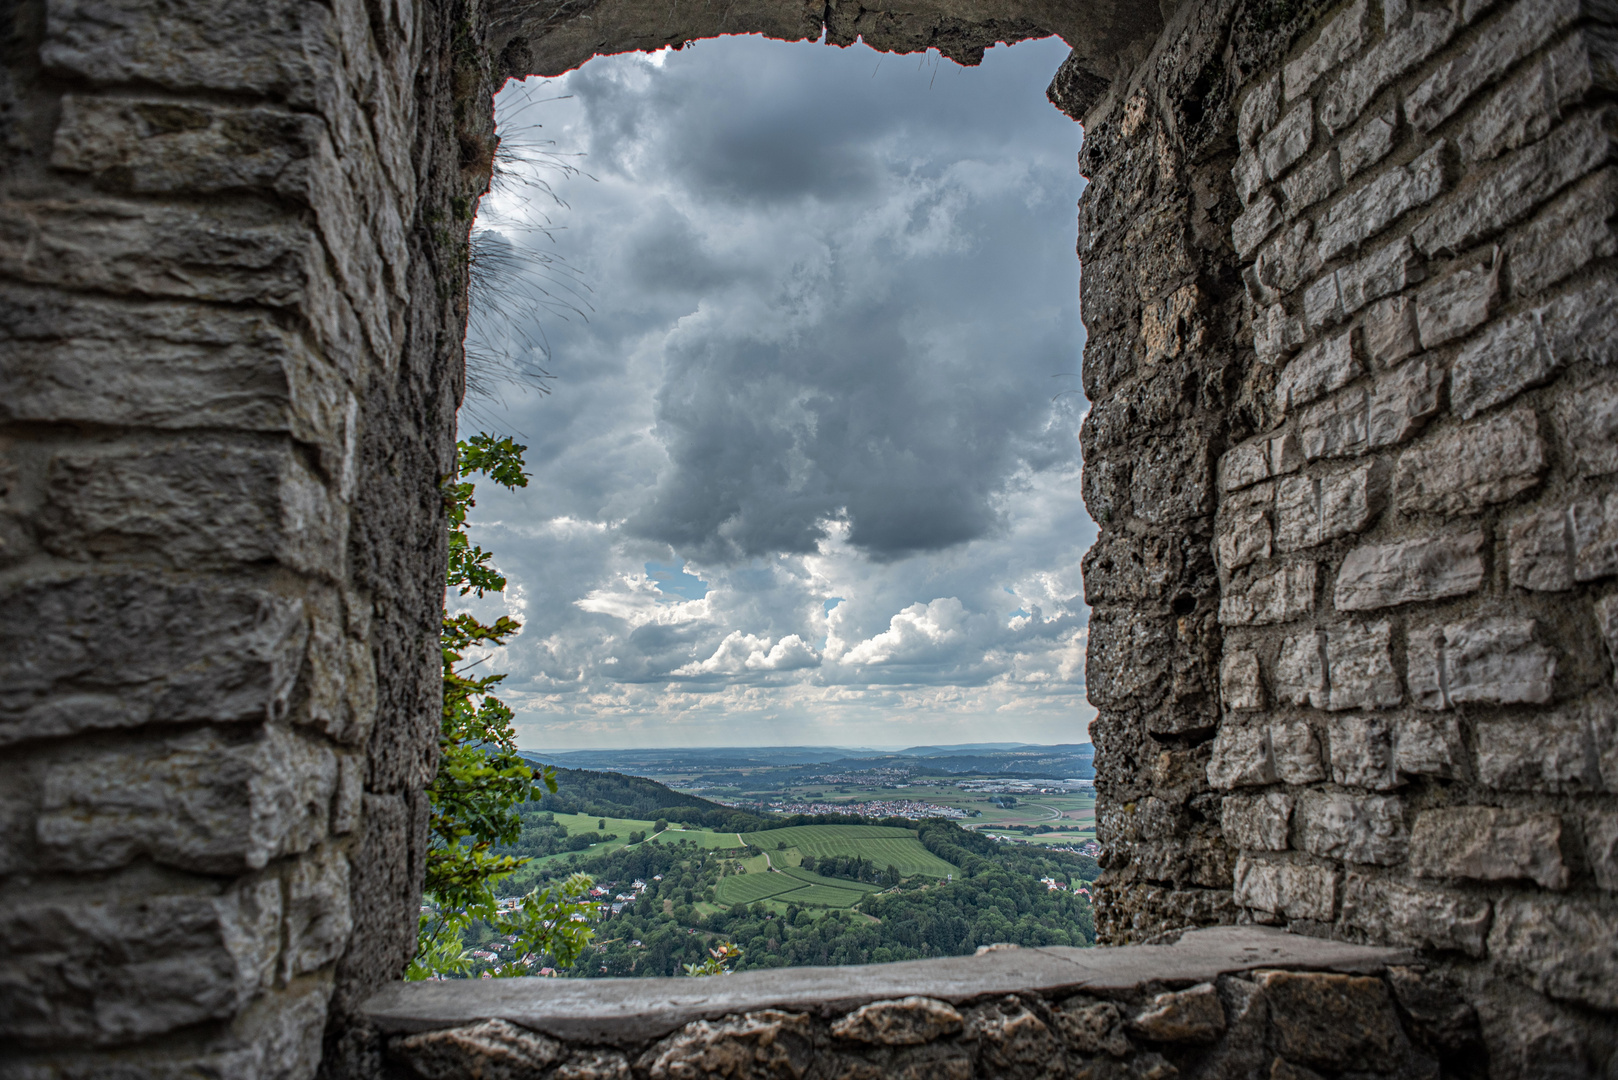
[1489,895,1618,1012]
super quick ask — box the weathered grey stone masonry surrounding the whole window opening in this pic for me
[0,0,1618,1080]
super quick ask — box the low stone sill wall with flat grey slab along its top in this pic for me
[369,928,1480,1080]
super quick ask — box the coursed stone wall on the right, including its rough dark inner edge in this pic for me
[1079,0,1618,1075]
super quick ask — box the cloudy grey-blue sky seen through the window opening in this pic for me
[469,37,1095,750]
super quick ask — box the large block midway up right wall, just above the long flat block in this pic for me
[1393,408,1548,517]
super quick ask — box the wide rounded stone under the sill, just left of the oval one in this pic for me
[636,1009,814,1080]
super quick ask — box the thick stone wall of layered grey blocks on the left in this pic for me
[0,0,492,1077]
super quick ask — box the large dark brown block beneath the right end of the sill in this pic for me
[1254,972,1408,1070]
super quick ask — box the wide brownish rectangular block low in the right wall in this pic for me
[1409,806,1568,889]
